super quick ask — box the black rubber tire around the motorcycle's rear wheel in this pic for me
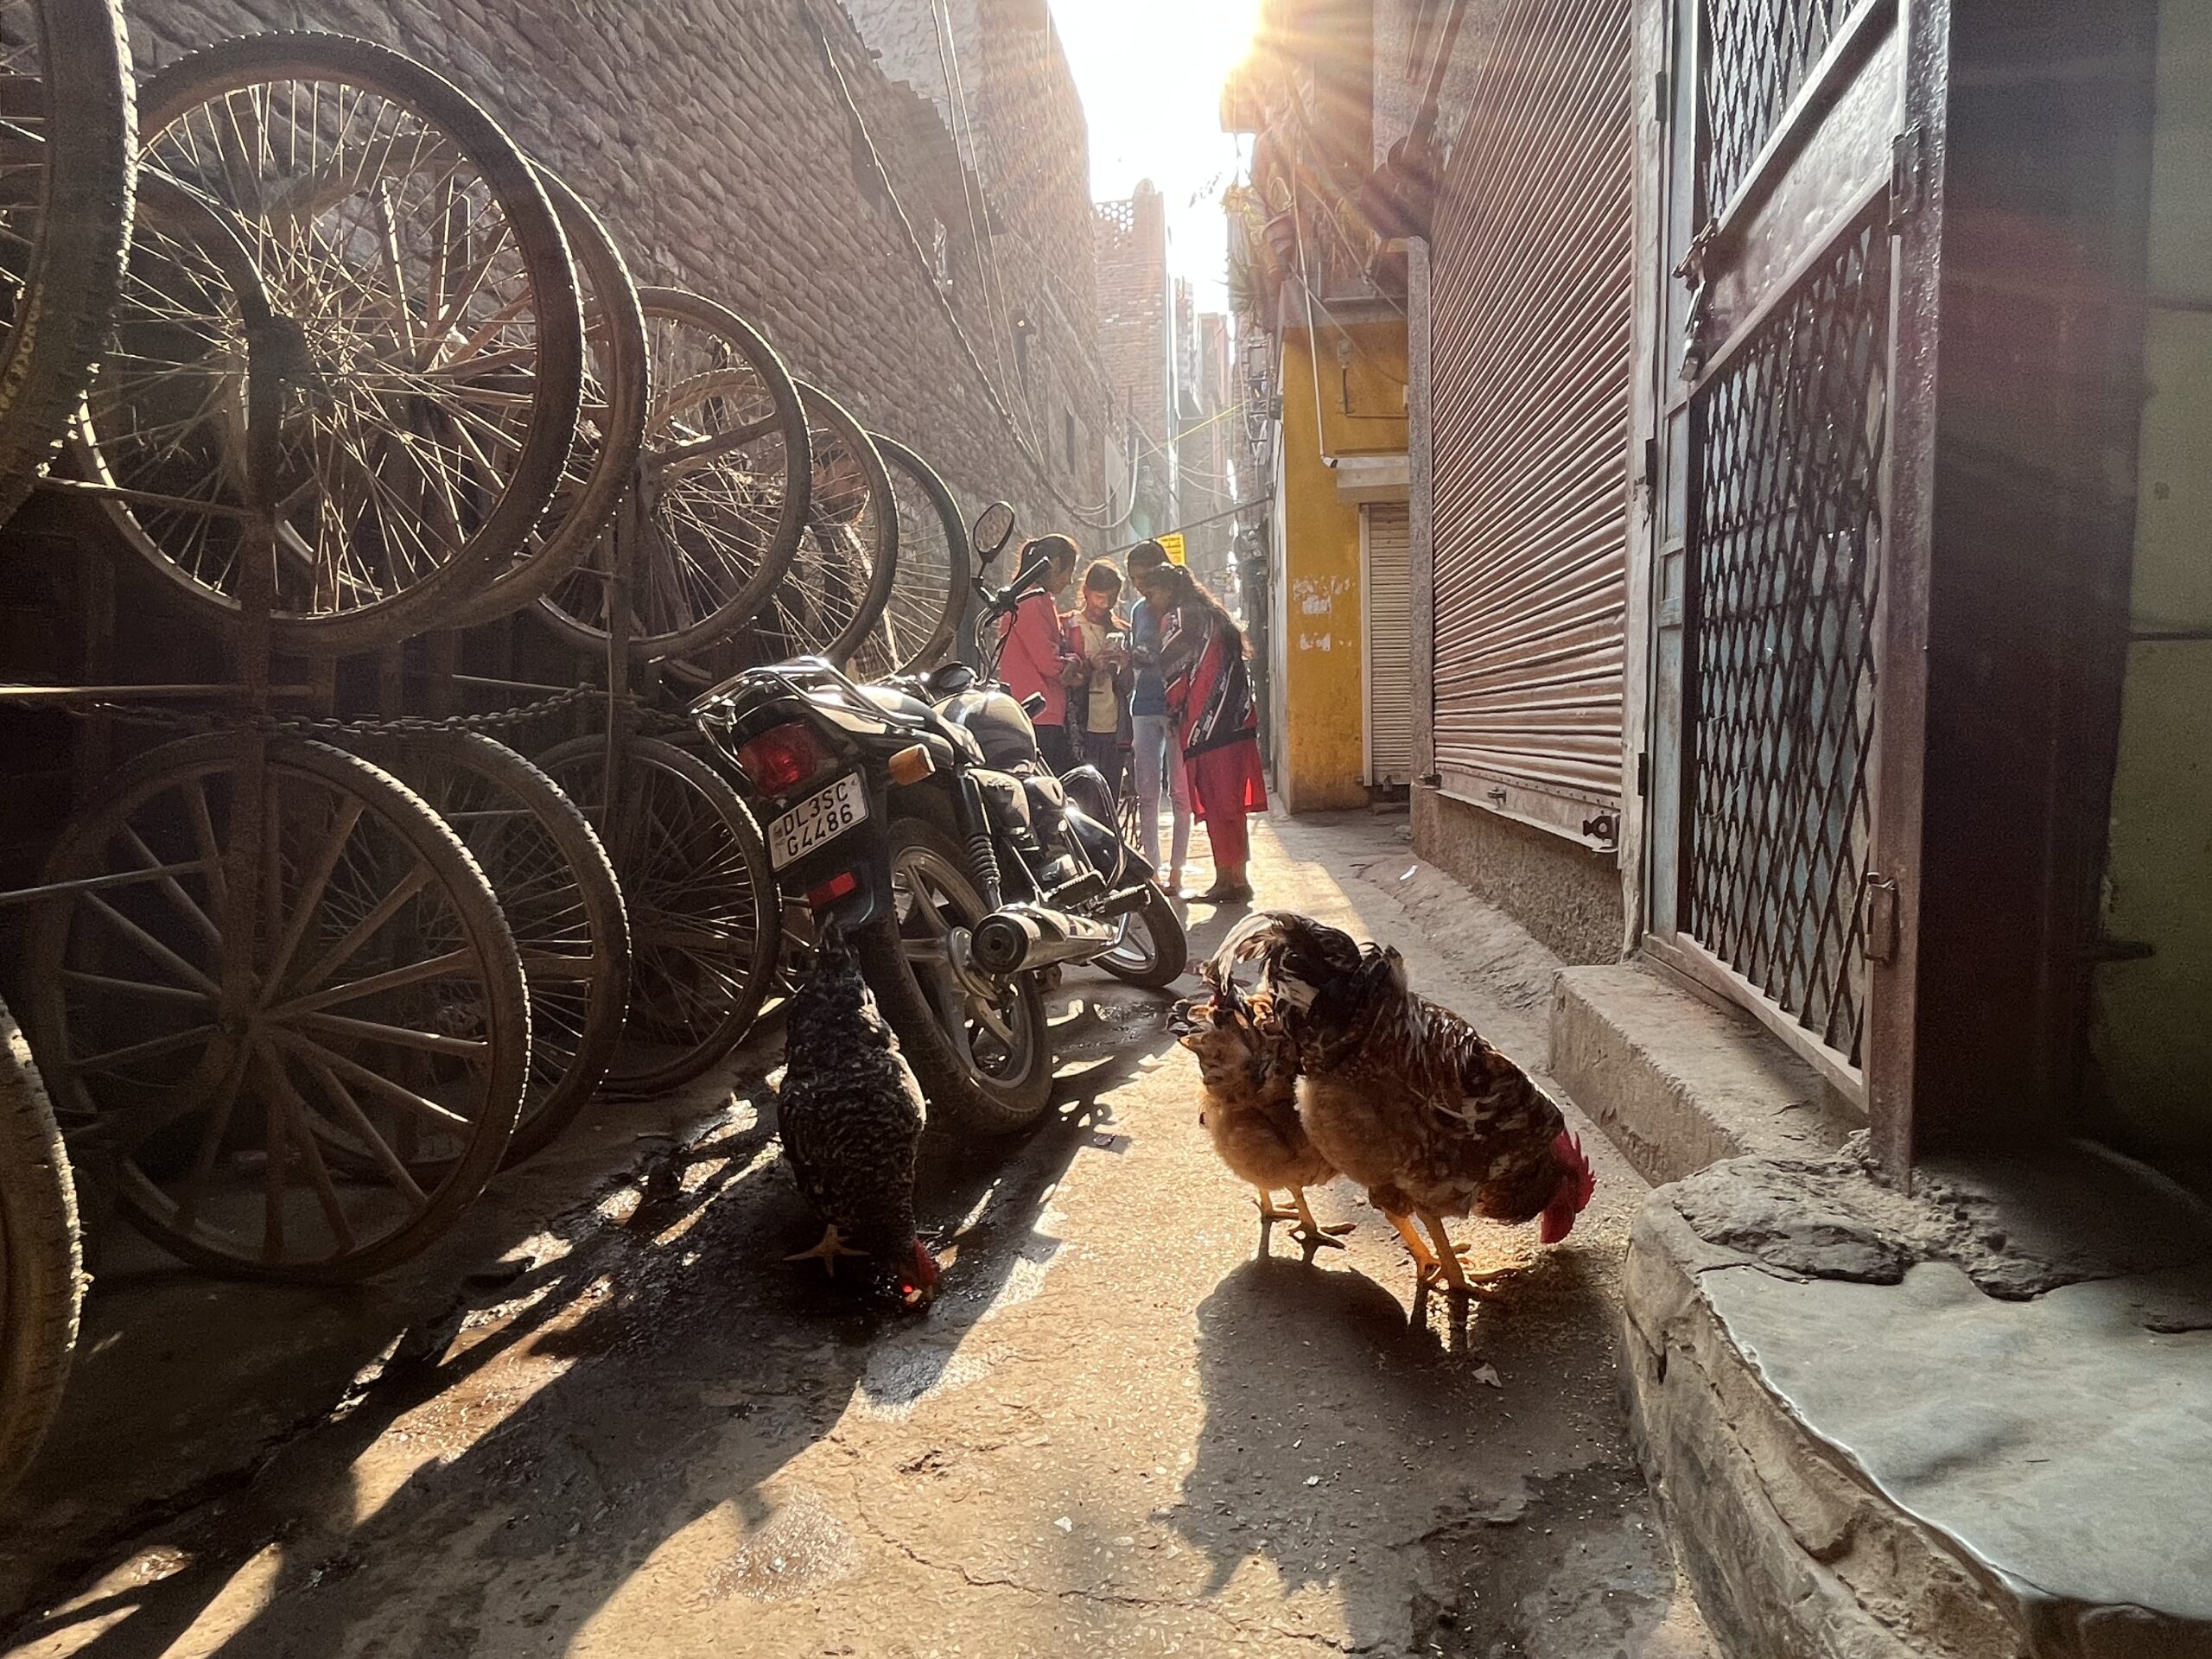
[854,818,1053,1137]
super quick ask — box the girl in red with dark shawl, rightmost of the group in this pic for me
[1159,564,1268,905]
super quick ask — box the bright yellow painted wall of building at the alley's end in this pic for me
[1276,323,1405,812]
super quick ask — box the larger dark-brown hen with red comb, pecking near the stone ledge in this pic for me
[1210,912,1597,1299]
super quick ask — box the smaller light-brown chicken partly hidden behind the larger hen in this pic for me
[1179,976,1351,1263]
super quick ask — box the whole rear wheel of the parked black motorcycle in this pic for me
[856,818,1053,1135]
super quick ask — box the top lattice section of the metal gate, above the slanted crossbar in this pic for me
[1699,0,1869,214]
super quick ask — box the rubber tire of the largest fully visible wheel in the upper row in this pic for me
[122,29,584,657]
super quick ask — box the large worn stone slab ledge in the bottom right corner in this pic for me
[1621,1148,2212,1659]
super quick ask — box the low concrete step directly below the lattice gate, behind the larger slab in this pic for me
[1548,963,1863,1185]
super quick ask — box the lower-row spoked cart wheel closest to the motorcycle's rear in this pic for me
[537,736,783,1095]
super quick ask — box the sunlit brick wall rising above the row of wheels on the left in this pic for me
[128,0,1103,529]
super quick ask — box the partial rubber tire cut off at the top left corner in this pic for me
[0,0,137,522]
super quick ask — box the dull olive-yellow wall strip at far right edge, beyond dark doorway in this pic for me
[2093,0,2212,1148]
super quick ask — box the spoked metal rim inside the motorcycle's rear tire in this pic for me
[892,845,1042,1086]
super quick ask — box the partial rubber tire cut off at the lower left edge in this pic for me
[0,1002,84,1493]
